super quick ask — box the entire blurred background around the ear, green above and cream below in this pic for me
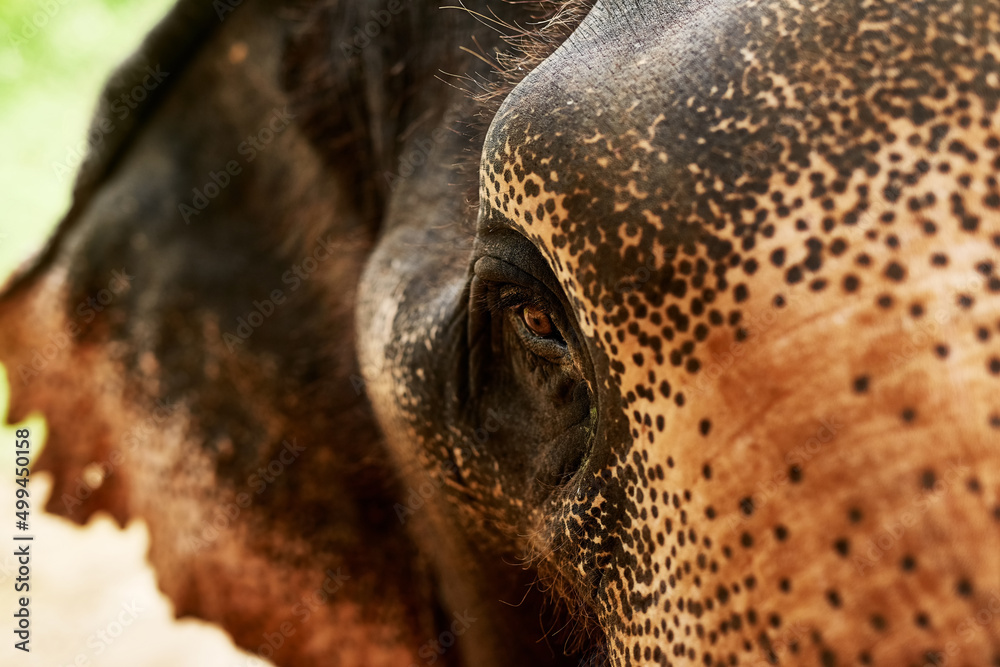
[0,0,264,667]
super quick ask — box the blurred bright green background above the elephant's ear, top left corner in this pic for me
[0,0,172,278]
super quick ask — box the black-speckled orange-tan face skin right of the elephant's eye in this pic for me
[464,2,1000,665]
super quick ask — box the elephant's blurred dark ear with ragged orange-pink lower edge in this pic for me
[0,0,434,664]
